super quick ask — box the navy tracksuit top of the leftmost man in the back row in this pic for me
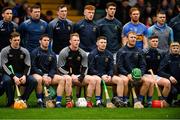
[0,20,18,51]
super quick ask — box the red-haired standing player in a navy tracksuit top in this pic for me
[74,5,99,52]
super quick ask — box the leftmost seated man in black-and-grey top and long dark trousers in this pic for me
[1,32,37,106]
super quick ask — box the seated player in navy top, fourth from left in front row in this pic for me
[88,36,124,107]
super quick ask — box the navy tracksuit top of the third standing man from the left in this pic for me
[49,18,73,54]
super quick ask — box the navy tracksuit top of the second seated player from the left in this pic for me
[31,47,57,78]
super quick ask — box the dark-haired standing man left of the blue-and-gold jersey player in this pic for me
[97,2,122,60]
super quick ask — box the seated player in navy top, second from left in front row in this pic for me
[31,34,65,108]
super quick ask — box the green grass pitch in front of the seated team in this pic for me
[0,87,180,119]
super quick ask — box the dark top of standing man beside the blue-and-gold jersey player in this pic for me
[97,18,122,53]
